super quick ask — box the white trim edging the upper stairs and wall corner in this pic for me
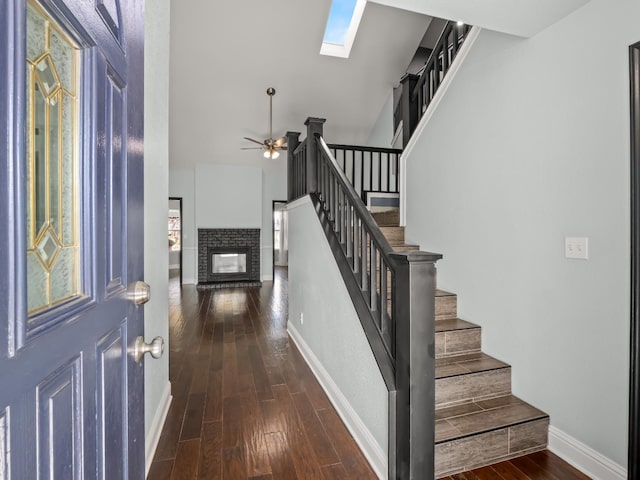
[400,26,482,227]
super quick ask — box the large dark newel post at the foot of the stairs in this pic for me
[389,252,442,480]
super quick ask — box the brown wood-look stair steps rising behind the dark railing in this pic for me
[373,209,549,478]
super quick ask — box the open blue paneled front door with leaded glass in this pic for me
[0,0,144,480]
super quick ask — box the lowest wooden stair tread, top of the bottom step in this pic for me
[435,395,549,444]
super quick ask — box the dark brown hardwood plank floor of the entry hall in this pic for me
[147,269,588,480]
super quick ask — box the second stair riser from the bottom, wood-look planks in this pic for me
[436,367,511,408]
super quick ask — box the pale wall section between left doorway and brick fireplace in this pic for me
[165,169,198,283]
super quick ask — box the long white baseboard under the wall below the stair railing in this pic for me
[287,323,388,480]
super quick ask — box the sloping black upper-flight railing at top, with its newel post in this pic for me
[394,22,472,147]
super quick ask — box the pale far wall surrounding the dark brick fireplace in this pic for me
[169,161,287,283]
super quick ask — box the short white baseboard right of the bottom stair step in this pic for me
[549,425,627,480]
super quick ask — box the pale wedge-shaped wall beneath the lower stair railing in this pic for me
[288,196,388,478]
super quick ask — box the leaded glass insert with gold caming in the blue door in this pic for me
[26,0,82,314]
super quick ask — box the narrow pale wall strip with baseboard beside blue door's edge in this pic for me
[144,0,171,466]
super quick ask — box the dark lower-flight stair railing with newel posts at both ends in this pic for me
[287,118,441,480]
